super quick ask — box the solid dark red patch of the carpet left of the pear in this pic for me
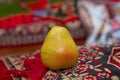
[0,53,47,80]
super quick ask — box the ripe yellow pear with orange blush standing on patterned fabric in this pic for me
[41,26,78,70]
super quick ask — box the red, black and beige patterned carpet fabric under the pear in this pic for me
[0,45,120,80]
